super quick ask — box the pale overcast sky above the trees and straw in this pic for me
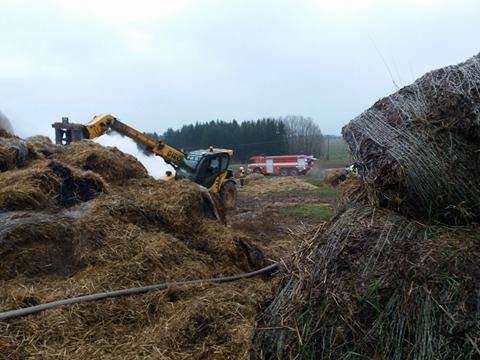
[0,0,480,136]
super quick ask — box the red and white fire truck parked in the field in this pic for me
[247,155,317,176]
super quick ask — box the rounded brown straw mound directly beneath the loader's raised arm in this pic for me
[53,140,149,185]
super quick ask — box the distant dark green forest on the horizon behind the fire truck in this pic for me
[148,116,324,161]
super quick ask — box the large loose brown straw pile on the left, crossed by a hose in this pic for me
[0,135,272,359]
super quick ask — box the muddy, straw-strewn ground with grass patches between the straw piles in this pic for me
[227,176,337,268]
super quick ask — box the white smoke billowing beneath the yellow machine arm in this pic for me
[95,132,174,179]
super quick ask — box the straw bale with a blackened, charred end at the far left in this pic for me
[0,161,106,211]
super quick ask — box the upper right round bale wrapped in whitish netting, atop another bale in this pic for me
[342,54,480,224]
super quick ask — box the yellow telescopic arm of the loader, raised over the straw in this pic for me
[85,114,185,166]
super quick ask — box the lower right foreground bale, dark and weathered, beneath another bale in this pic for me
[251,205,480,359]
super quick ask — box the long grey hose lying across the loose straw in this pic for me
[0,263,279,321]
